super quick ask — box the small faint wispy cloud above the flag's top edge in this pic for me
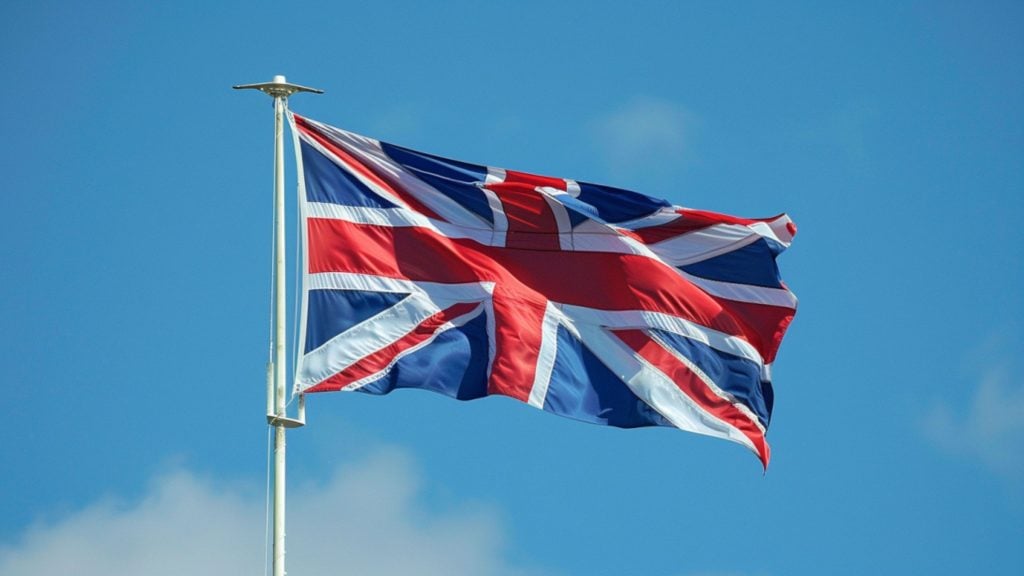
[591,96,693,172]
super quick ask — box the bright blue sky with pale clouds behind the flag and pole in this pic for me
[0,1,1024,576]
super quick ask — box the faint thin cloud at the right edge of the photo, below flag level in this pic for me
[924,366,1024,480]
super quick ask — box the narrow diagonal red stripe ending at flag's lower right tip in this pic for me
[612,330,771,468]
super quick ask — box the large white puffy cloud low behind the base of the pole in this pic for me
[0,451,544,576]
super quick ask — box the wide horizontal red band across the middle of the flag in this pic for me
[307,218,779,357]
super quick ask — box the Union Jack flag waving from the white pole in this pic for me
[292,115,797,466]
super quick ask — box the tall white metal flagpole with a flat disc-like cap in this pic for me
[234,76,324,576]
